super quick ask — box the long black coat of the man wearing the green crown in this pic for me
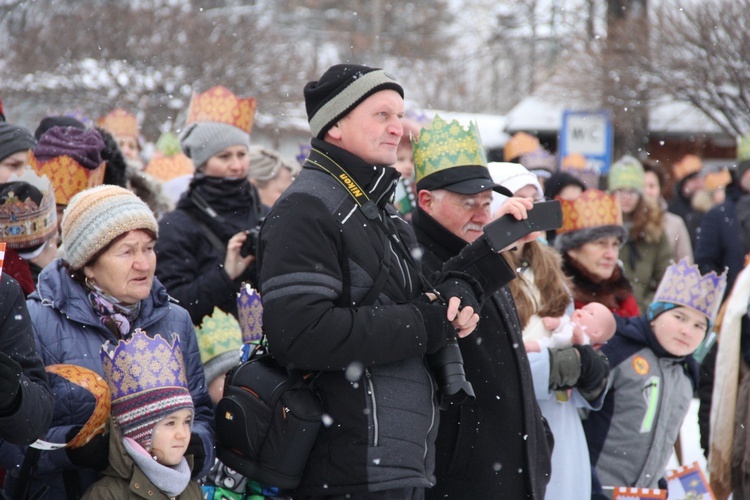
[412,209,552,499]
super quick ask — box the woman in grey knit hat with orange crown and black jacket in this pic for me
[156,86,266,325]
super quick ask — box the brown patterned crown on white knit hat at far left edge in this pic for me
[0,166,57,251]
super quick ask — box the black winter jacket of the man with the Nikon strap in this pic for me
[258,139,455,496]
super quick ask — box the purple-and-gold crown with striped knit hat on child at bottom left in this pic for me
[100,328,193,450]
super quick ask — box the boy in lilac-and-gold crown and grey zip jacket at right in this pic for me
[584,259,726,498]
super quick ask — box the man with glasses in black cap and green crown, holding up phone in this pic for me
[412,116,552,499]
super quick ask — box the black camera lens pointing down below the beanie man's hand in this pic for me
[427,339,476,410]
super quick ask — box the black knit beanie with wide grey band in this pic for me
[304,64,404,139]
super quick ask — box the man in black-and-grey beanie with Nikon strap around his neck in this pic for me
[257,64,481,499]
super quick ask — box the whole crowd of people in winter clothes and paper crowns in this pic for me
[0,64,750,500]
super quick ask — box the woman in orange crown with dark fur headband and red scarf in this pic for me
[555,189,639,316]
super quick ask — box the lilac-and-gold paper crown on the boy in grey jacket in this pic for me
[653,258,727,322]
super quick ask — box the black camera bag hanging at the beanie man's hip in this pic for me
[214,353,323,489]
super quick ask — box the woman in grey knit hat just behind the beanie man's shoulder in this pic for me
[248,146,302,208]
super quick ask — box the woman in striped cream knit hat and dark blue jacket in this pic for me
[0,185,214,499]
